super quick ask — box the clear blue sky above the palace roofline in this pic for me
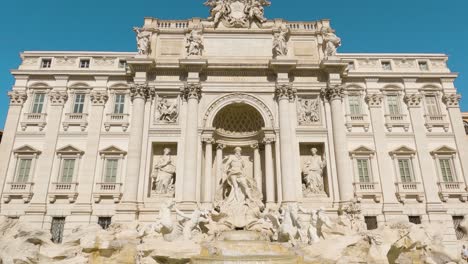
[0,0,468,129]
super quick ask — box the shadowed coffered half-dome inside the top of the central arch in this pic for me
[213,103,265,138]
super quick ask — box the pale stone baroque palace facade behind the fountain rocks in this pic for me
[0,0,468,245]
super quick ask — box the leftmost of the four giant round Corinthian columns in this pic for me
[123,83,154,207]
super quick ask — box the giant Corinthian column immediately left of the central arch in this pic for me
[181,83,202,204]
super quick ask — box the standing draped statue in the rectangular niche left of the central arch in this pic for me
[151,148,176,194]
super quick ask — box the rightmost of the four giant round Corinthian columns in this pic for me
[322,84,353,202]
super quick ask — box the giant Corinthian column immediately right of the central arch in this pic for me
[275,83,297,203]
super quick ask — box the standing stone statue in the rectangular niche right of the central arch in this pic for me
[302,148,327,195]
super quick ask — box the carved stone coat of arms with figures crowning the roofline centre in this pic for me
[205,0,271,28]
